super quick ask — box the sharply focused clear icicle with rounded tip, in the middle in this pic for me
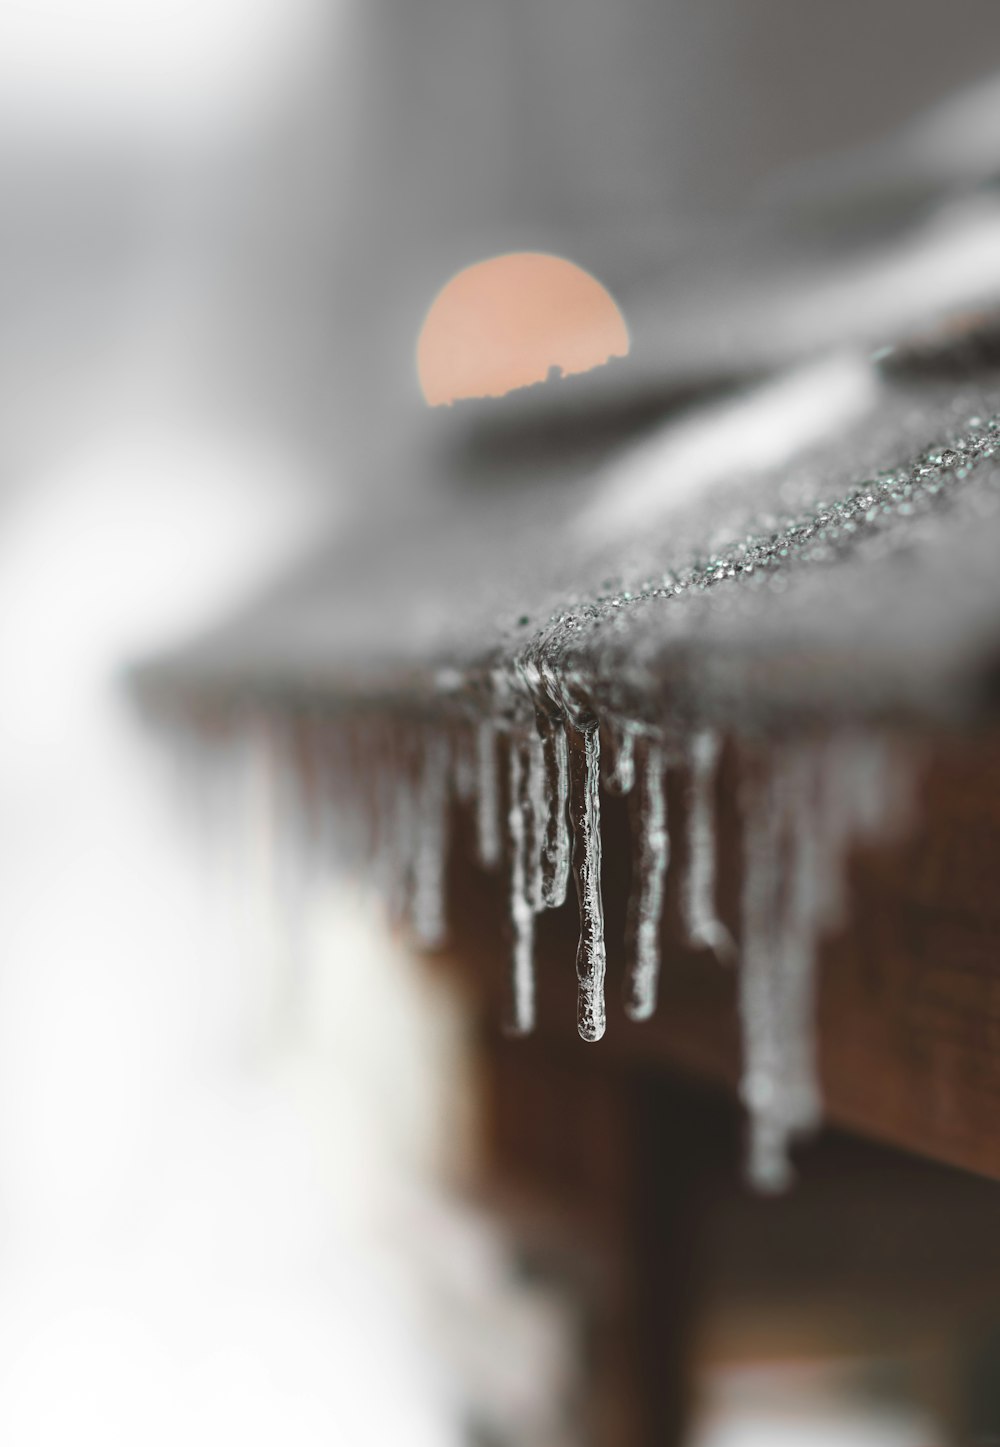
[570,728,606,1040]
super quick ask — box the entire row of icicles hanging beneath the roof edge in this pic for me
[164,694,910,1191]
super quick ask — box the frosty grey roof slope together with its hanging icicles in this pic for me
[140,347,1000,1189]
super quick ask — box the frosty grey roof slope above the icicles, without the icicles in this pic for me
[145,363,1000,726]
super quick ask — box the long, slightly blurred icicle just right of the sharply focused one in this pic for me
[625,744,670,1020]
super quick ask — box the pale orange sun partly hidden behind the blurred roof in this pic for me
[417,252,628,407]
